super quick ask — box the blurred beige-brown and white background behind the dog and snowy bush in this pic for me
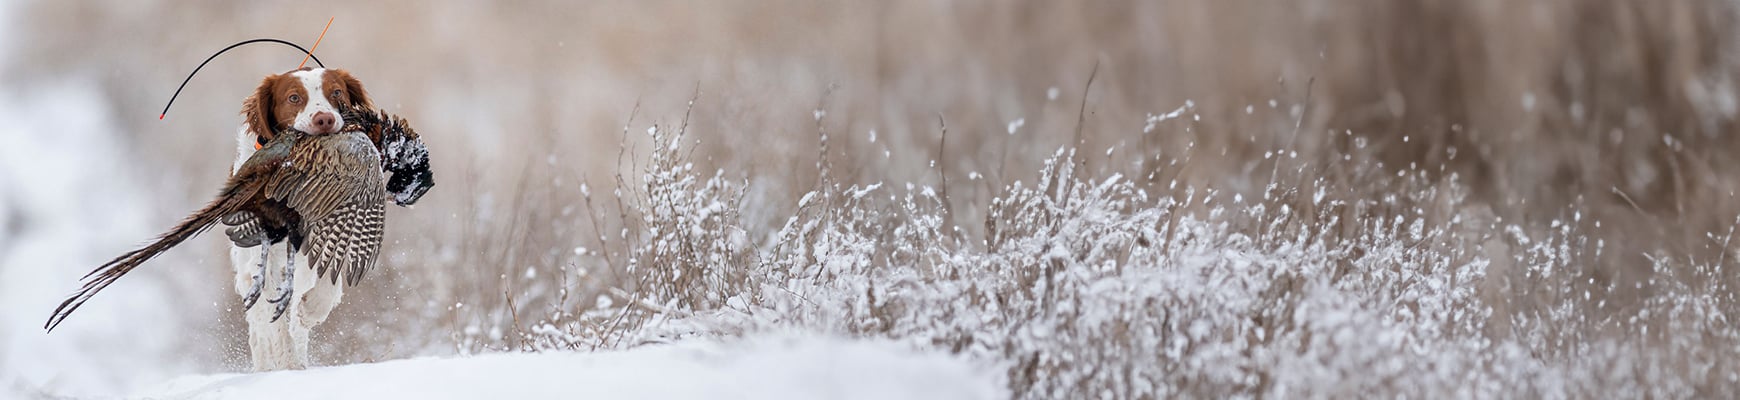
[0,0,1740,393]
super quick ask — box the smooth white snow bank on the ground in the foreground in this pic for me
[136,334,1009,400]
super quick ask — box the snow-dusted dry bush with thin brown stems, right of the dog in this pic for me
[455,93,1740,398]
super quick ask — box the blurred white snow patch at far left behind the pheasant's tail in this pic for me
[0,82,193,398]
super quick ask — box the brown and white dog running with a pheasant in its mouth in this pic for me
[230,68,372,370]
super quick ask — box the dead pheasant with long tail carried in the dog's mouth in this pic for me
[44,125,389,330]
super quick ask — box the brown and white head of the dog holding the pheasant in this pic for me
[242,68,372,152]
